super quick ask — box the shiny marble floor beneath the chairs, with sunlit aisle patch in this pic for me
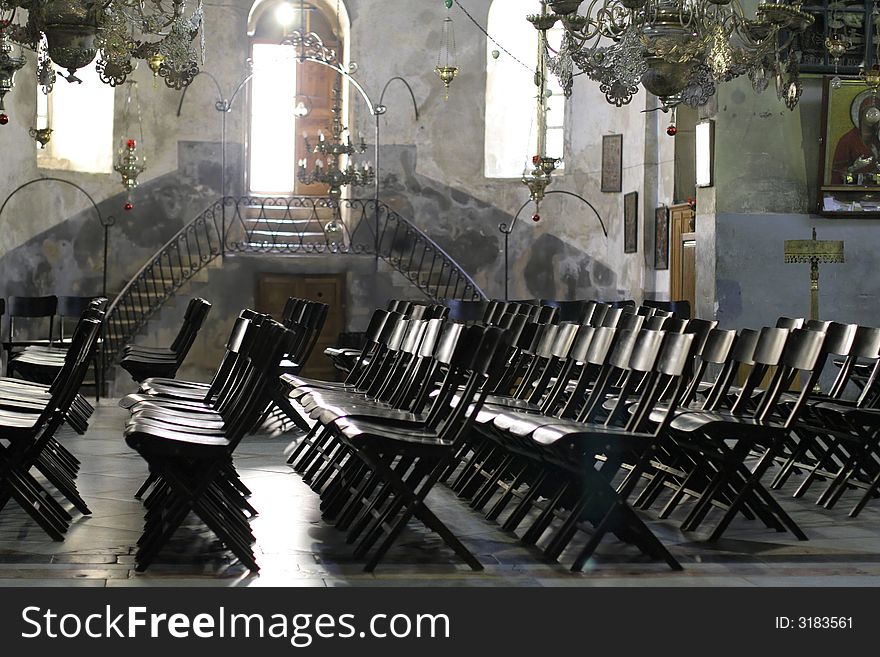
[0,401,880,587]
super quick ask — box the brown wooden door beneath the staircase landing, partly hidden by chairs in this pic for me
[255,274,345,380]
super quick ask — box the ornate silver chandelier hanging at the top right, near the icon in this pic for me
[540,0,813,109]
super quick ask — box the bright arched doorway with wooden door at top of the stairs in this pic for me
[248,0,347,195]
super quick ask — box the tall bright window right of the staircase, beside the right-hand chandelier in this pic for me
[484,0,565,178]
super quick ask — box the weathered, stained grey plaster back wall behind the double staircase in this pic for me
[0,0,674,376]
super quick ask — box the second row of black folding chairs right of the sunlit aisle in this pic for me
[445,309,714,568]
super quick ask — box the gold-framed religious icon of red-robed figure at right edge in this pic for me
[817,77,880,217]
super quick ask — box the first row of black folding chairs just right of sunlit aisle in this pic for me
[282,310,505,571]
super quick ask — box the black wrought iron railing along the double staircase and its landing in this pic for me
[104,196,486,368]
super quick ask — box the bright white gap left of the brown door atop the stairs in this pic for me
[249,43,297,194]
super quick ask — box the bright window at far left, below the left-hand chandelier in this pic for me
[36,62,114,173]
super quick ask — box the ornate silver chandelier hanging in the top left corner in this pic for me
[0,0,204,120]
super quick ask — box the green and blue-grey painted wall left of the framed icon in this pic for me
[697,78,880,327]
